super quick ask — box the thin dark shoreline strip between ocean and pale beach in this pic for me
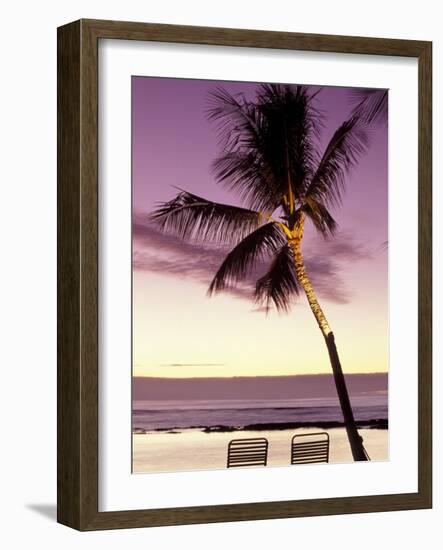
[133,418,388,434]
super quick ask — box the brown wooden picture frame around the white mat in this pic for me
[57,20,432,531]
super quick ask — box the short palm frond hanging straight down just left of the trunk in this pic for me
[255,244,299,312]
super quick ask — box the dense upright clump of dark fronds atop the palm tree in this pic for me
[208,84,322,213]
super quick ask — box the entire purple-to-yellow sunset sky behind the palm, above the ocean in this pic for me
[132,77,388,378]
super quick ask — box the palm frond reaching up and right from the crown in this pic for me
[305,117,369,209]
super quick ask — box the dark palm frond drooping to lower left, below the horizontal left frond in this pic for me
[208,222,286,295]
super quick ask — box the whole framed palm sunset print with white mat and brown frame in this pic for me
[58,20,432,530]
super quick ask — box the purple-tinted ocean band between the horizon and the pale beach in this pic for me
[133,374,388,433]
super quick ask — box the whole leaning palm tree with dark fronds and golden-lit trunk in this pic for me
[151,84,368,460]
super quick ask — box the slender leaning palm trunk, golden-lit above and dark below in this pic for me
[289,235,368,461]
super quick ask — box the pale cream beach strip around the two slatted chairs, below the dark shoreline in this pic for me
[133,428,389,473]
